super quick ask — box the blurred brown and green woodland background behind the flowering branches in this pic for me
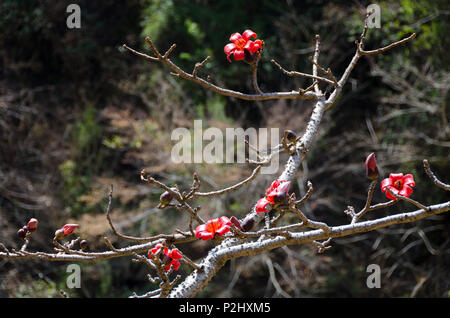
[0,0,450,297]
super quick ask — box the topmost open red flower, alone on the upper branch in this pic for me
[223,30,263,62]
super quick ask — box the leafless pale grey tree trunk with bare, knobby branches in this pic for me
[0,14,450,297]
